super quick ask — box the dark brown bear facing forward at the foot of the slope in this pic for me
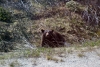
[41,29,65,47]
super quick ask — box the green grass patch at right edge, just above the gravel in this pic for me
[68,39,100,50]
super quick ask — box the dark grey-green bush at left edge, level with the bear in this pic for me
[0,31,15,52]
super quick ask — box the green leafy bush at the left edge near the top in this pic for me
[0,7,12,23]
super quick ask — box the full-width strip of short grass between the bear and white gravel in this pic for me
[0,40,100,60]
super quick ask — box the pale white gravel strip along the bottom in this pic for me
[0,49,100,67]
